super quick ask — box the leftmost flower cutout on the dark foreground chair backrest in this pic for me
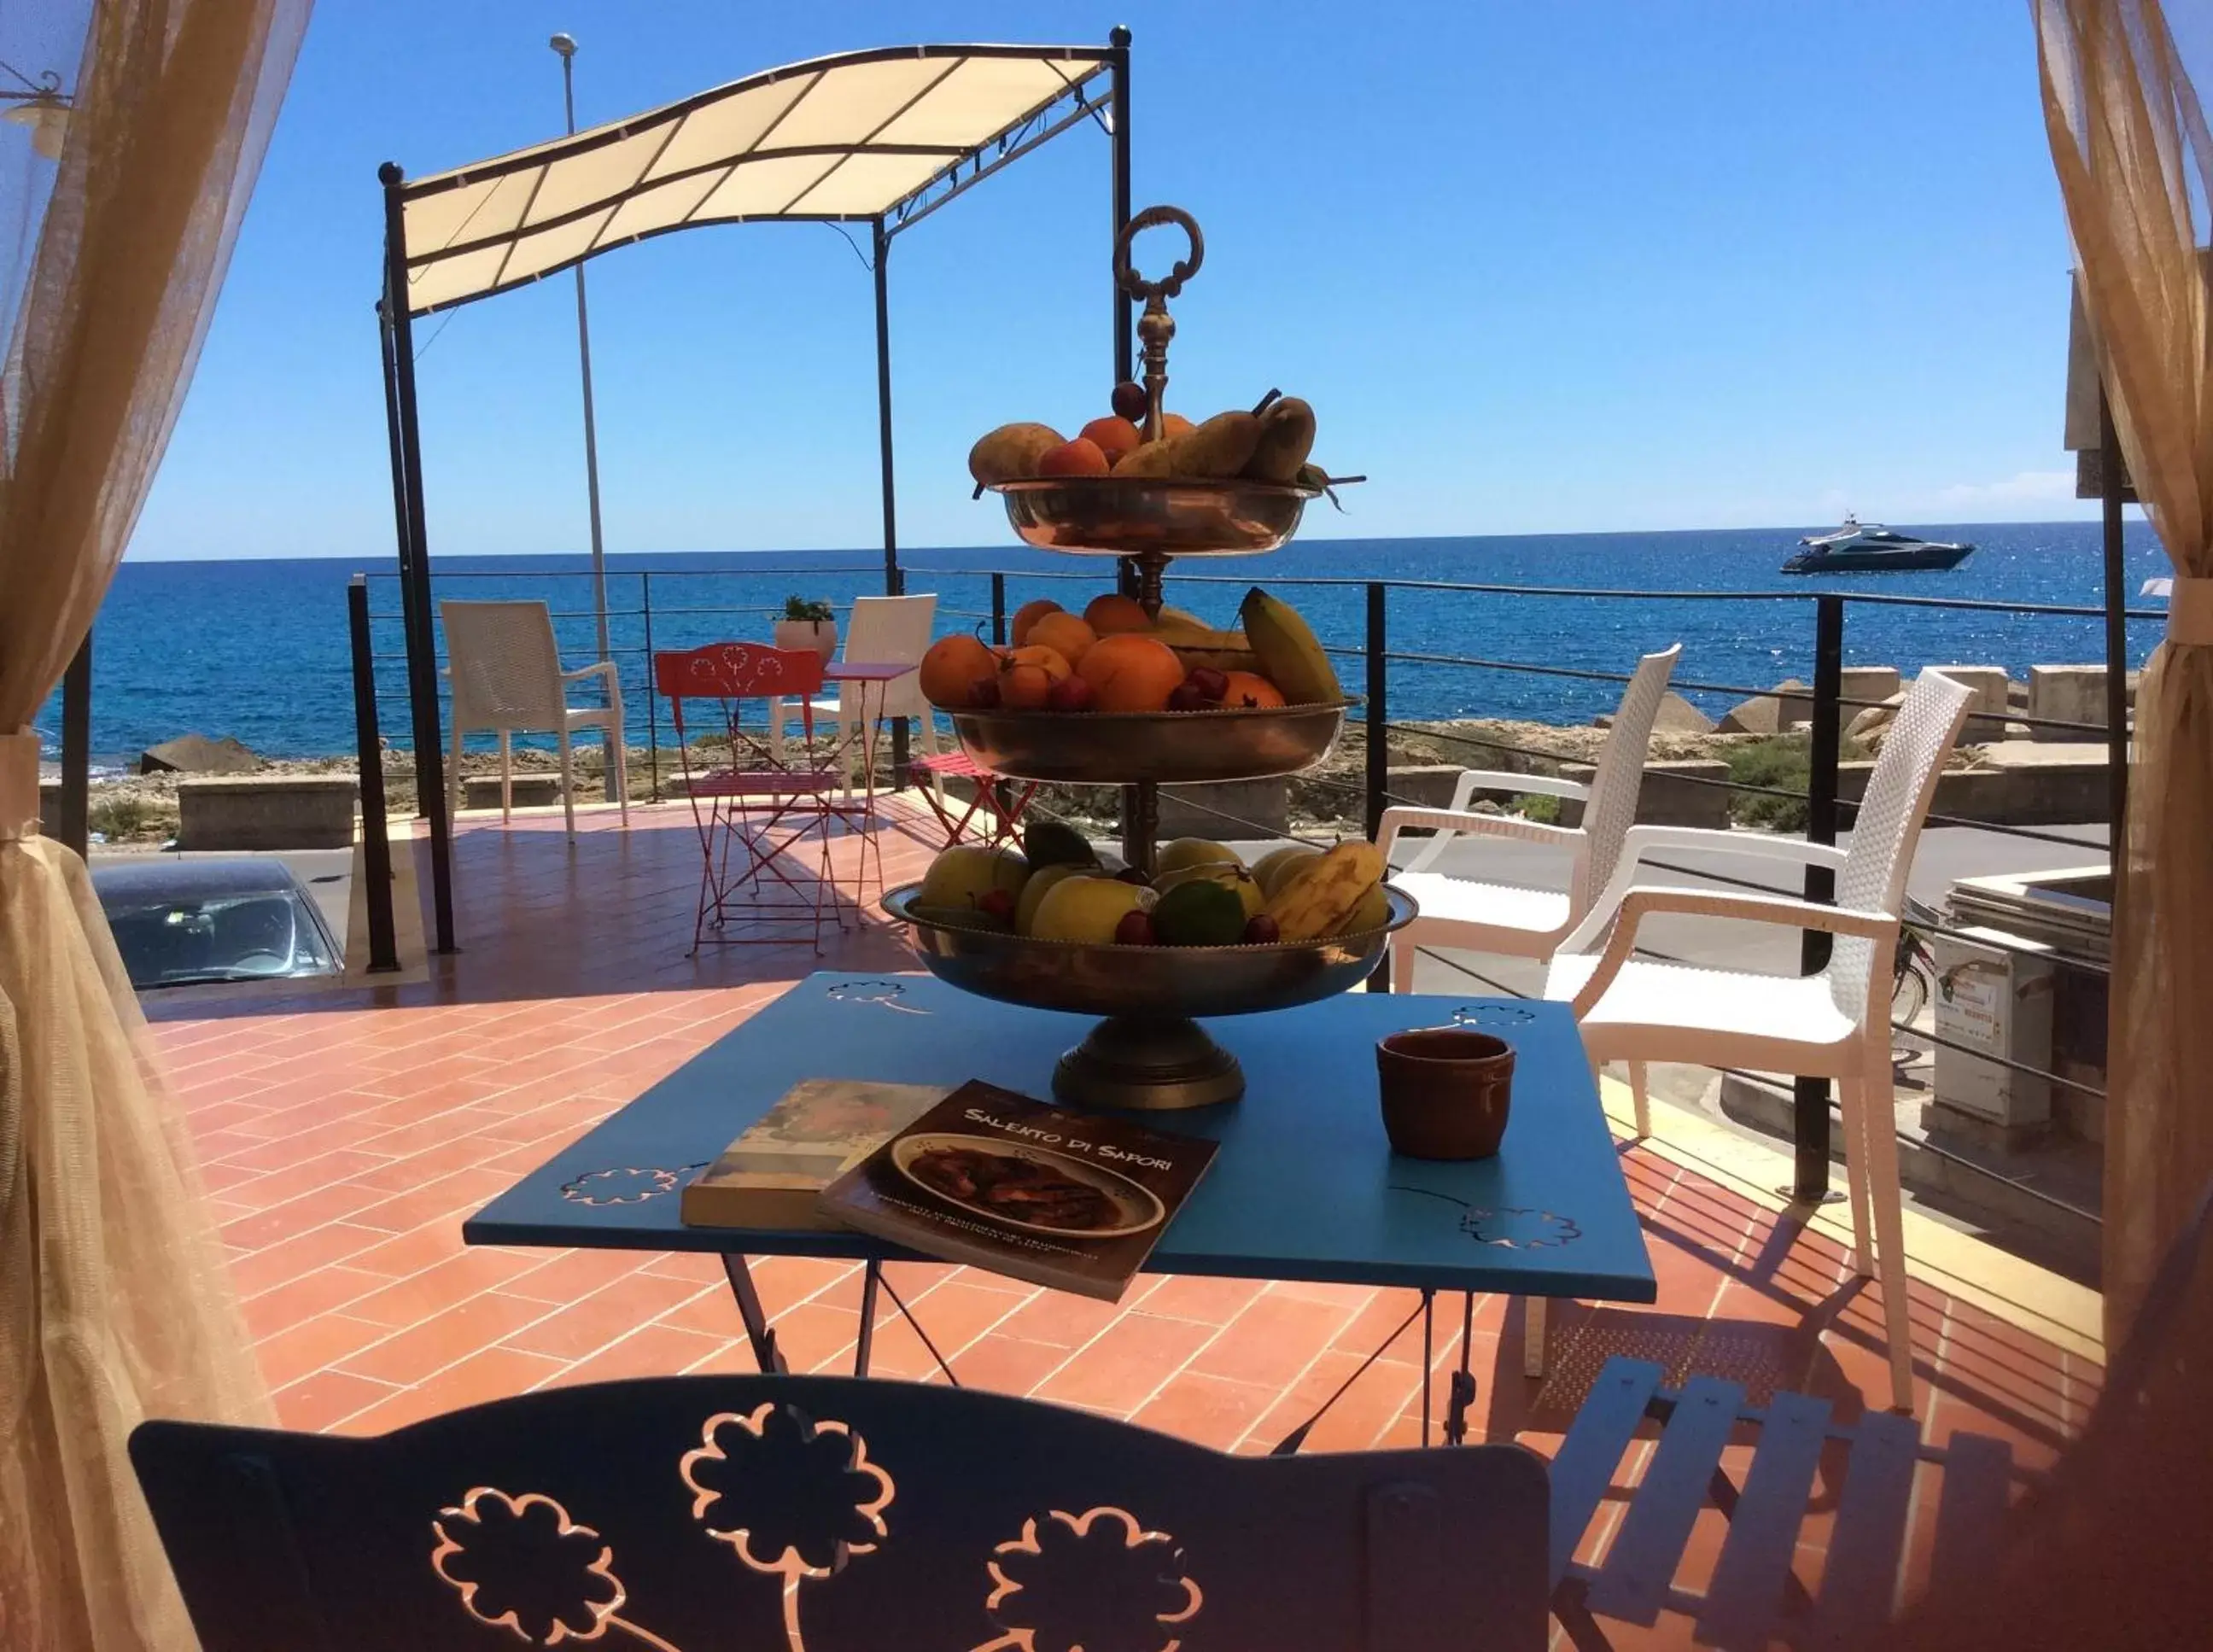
[429,1486,675,1652]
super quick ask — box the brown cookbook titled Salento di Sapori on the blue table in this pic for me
[821,1079,1215,1303]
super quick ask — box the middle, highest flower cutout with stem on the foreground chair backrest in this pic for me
[680,1400,894,1652]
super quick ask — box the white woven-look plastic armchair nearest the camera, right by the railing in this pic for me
[1529,672,1974,1409]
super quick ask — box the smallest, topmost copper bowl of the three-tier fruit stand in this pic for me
[991,476,1321,557]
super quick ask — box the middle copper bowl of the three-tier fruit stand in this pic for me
[947,701,1357,785]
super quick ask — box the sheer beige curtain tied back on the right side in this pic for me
[2031,0,2213,1347]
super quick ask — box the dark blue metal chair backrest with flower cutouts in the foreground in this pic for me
[131,1375,1547,1652]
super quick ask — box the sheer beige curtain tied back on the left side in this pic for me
[0,0,307,1652]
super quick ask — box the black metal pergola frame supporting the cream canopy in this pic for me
[377,26,1133,953]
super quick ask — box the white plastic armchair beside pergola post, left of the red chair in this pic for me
[438,602,631,838]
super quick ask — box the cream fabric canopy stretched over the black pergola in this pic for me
[400,46,1109,314]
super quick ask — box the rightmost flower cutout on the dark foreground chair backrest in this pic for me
[973,1509,1204,1652]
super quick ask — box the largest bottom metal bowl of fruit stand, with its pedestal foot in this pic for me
[883,883,1416,1110]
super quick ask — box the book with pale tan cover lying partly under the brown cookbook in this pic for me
[677,1079,945,1229]
